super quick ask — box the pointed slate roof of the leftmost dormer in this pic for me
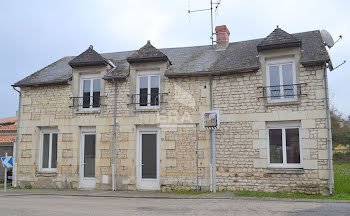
[69,45,108,67]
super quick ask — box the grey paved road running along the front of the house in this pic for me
[0,195,350,216]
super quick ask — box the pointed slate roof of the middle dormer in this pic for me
[126,41,169,63]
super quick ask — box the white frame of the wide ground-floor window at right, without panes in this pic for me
[266,121,304,169]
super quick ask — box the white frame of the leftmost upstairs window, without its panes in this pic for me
[79,74,102,111]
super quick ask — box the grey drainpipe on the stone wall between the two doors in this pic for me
[112,79,117,191]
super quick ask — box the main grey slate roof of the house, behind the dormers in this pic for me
[14,30,330,86]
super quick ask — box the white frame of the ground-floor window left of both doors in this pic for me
[39,129,58,173]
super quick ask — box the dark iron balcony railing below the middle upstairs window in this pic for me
[131,93,167,108]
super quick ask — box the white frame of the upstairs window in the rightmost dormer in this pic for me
[266,57,298,103]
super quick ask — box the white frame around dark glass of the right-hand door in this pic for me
[136,126,160,190]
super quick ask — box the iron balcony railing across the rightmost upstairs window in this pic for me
[258,83,306,103]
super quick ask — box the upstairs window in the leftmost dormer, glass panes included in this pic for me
[80,76,101,109]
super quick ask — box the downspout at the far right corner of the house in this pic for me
[323,65,333,195]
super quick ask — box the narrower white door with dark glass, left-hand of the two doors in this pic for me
[79,130,96,189]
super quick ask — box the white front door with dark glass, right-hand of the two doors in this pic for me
[137,129,160,190]
